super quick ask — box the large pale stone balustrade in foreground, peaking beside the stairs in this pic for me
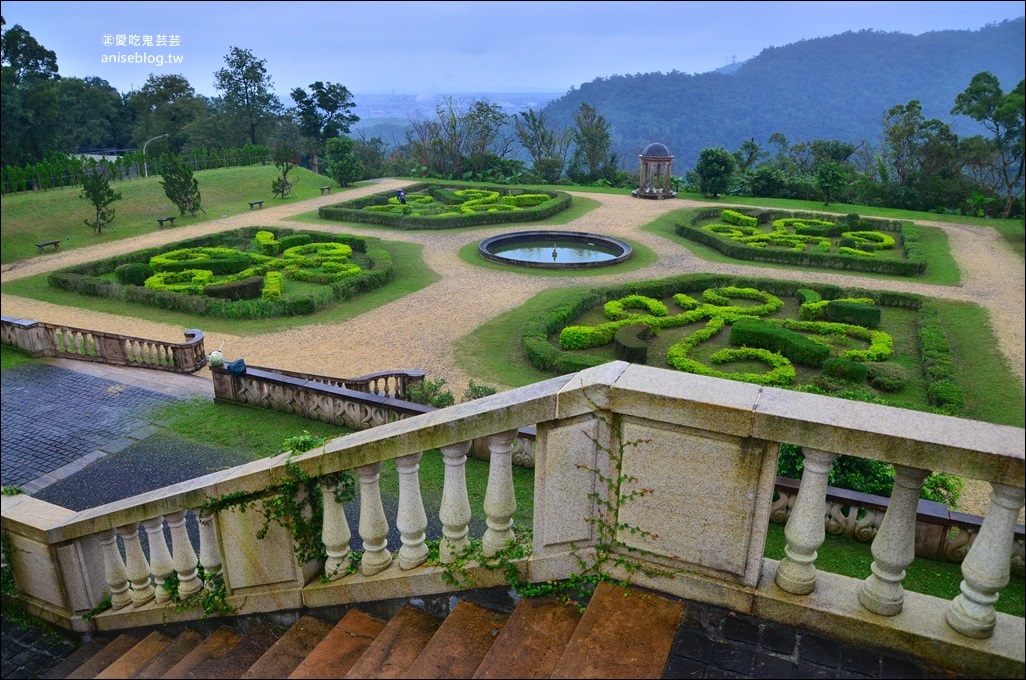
[2,362,1026,677]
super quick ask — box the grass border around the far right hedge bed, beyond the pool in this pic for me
[641,206,961,286]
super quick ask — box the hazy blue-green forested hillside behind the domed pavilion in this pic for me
[543,18,1026,169]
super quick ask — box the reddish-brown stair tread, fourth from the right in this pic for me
[346,604,441,678]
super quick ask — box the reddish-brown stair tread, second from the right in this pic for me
[474,598,581,678]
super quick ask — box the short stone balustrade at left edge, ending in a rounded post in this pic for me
[0,316,206,373]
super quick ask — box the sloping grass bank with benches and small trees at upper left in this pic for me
[0,165,348,263]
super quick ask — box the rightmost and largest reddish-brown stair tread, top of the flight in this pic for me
[552,583,684,678]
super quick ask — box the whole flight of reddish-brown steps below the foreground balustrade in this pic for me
[43,583,684,678]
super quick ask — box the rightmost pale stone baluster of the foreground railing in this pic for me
[946,484,1026,640]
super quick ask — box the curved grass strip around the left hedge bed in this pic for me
[0,241,439,336]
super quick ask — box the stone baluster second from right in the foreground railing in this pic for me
[859,466,930,616]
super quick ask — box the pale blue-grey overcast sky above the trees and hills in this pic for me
[2,0,1026,97]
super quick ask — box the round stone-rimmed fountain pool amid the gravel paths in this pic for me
[477,232,632,269]
